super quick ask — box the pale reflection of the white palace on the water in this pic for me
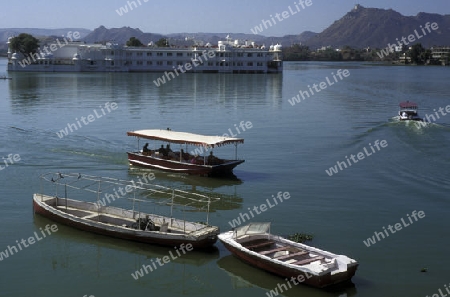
[9,72,283,111]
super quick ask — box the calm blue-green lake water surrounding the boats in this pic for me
[0,59,450,297]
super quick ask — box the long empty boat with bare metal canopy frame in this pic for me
[33,173,219,248]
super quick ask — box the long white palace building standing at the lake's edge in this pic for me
[8,36,283,73]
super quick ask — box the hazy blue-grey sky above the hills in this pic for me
[0,0,450,36]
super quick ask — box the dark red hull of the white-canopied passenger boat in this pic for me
[127,152,244,176]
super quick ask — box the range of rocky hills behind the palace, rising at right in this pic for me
[0,5,450,51]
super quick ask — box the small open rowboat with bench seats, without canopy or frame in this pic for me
[219,223,358,288]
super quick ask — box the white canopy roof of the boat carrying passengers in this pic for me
[127,129,244,147]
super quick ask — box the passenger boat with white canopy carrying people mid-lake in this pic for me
[127,130,244,176]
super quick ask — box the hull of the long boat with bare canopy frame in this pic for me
[33,194,219,248]
